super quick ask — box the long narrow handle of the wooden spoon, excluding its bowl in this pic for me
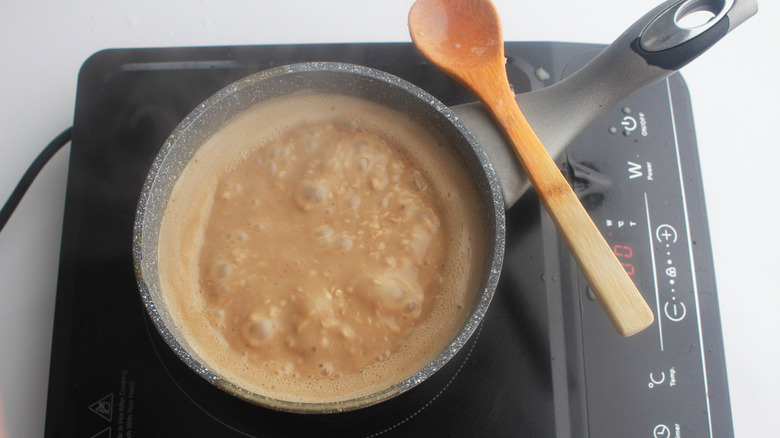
[471,65,654,336]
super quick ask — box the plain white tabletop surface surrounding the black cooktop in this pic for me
[0,0,780,437]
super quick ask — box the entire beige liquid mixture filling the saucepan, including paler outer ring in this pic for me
[159,93,485,402]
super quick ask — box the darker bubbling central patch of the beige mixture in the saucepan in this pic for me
[200,121,447,379]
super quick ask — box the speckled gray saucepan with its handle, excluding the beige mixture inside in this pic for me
[133,0,757,413]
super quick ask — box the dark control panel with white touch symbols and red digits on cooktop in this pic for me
[564,75,731,438]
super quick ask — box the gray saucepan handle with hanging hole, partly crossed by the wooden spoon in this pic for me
[452,0,758,208]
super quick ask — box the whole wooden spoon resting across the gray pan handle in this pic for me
[409,0,653,336]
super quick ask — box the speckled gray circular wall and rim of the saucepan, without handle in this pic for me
[133,63,504,412]
